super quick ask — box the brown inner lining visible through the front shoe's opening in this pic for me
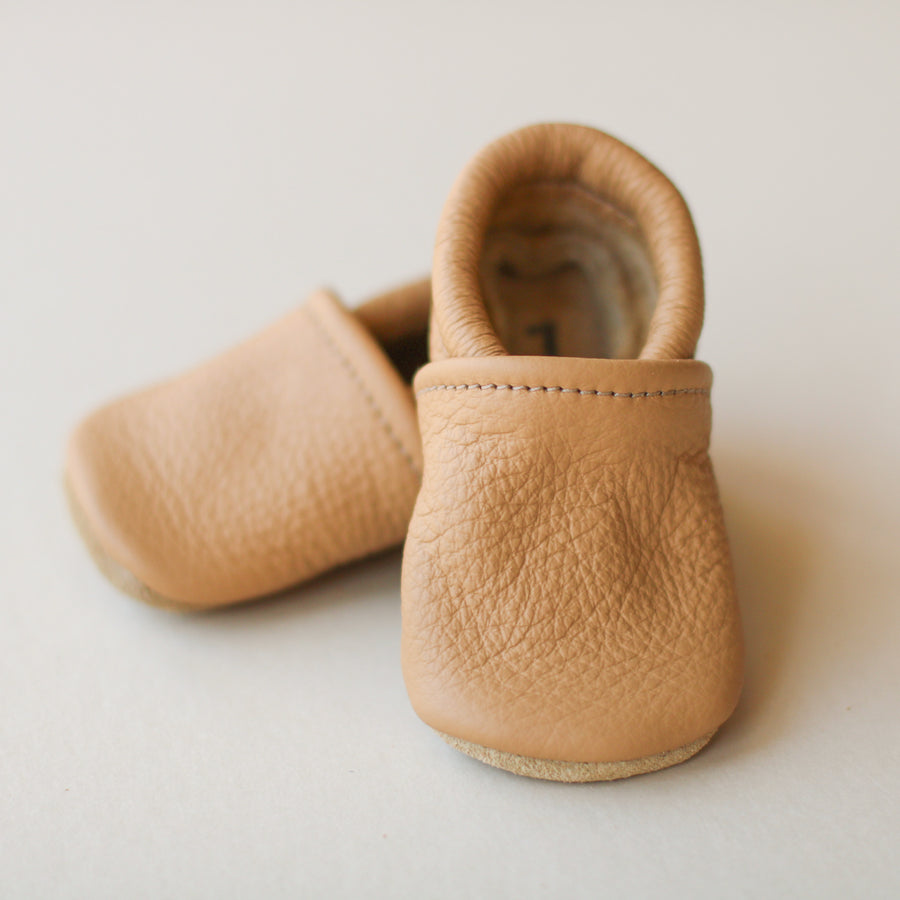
[479,182,658,359]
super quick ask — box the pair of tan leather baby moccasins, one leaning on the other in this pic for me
[66,124,742,781]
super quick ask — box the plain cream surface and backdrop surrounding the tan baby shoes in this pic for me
[0,0,900,900]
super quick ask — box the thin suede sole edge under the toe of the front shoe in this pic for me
[437,731,715,784]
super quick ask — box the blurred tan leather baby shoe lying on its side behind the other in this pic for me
[66,281,431,609]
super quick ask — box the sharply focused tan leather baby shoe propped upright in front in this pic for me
[403,125,742,781]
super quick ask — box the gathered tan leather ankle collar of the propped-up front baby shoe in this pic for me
[431,124,703,359]
